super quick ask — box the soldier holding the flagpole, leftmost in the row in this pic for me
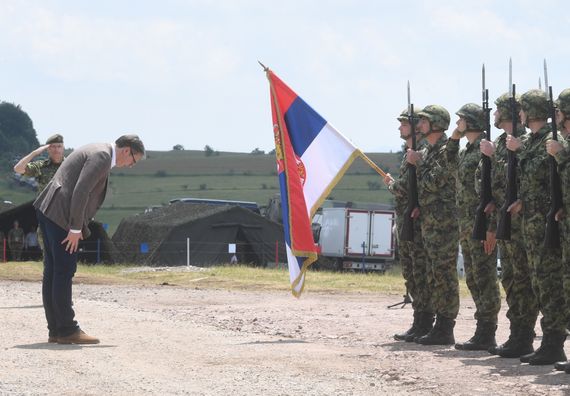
[384,109,434,342]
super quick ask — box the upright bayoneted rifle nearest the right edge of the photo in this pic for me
[544,59,562,248]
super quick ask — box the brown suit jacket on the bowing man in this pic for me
[34,143,113,238]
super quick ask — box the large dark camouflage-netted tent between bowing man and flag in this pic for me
[113,202,286,266]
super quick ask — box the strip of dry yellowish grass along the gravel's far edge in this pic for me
[0,262,468,297]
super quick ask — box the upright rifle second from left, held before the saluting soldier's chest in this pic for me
[471,64,493,241]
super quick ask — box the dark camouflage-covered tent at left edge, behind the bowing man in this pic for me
[0,201,116,263]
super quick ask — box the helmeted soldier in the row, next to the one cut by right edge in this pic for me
[507,89,567,365]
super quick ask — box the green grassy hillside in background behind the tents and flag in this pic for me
[0,150,401,235]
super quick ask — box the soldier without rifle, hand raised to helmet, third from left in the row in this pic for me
[447,103,501,351]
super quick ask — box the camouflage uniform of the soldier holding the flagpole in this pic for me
[389,150,433,312]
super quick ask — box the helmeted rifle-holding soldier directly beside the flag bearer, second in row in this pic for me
[406,105,459,345]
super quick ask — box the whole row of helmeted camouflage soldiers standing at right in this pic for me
[384,89,570,373]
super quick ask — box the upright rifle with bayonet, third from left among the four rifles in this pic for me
[497,59,516,241]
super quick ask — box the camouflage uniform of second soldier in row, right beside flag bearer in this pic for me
[418,134,459,320]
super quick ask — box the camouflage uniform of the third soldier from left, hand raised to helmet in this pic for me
[448,134,501,326]
